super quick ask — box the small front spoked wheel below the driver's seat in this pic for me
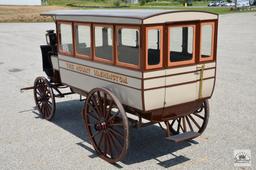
[34,77,55,120]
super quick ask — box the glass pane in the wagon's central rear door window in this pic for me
[169,27,194,62]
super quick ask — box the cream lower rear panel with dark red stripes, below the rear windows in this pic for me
[143,62,216,111]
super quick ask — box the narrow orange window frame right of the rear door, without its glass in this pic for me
[199,21,216,62]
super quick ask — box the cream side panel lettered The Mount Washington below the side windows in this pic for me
[59,54,143,110]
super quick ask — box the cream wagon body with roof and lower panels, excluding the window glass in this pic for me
[43,10,218,115]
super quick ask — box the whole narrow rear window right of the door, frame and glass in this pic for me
[200,23,214,60]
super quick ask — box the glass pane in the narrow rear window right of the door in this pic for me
[201,24,213,57]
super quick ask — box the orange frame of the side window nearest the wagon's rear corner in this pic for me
[115,25,142,69]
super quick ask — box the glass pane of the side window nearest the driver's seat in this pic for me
[60,24,73,53]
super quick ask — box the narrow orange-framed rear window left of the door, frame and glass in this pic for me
[146,26,162,68]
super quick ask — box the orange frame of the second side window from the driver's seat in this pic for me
[73,22,93,59]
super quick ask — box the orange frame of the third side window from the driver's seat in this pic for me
[92,24,115,65]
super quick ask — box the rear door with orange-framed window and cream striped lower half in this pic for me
[165,22,200,107]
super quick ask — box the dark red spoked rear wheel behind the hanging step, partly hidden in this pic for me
[169,100,209,135]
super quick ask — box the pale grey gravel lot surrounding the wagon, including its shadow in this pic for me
[0,13,256,170]
